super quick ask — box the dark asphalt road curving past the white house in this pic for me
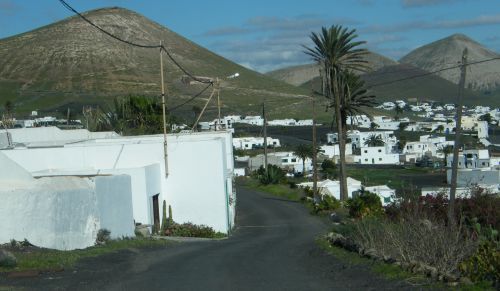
[0,188,410,290]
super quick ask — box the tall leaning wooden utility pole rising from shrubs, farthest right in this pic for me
[448,48,467,224]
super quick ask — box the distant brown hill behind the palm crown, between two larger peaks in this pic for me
[266,52,397,86]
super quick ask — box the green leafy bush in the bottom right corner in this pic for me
[459,241,500,285]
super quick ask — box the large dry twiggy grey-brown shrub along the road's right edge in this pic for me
[351,216,477,274]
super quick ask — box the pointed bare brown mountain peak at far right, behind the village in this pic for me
[400,34,500,91]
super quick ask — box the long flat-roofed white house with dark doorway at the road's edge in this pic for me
[2,131,236,233]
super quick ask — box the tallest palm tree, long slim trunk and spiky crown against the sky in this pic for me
[305,25,368,200]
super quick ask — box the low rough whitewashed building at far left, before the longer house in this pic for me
[0,152,134,250]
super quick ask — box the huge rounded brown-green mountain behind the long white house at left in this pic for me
[0,8,303,117]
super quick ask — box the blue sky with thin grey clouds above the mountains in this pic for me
[0,0,500,72]
